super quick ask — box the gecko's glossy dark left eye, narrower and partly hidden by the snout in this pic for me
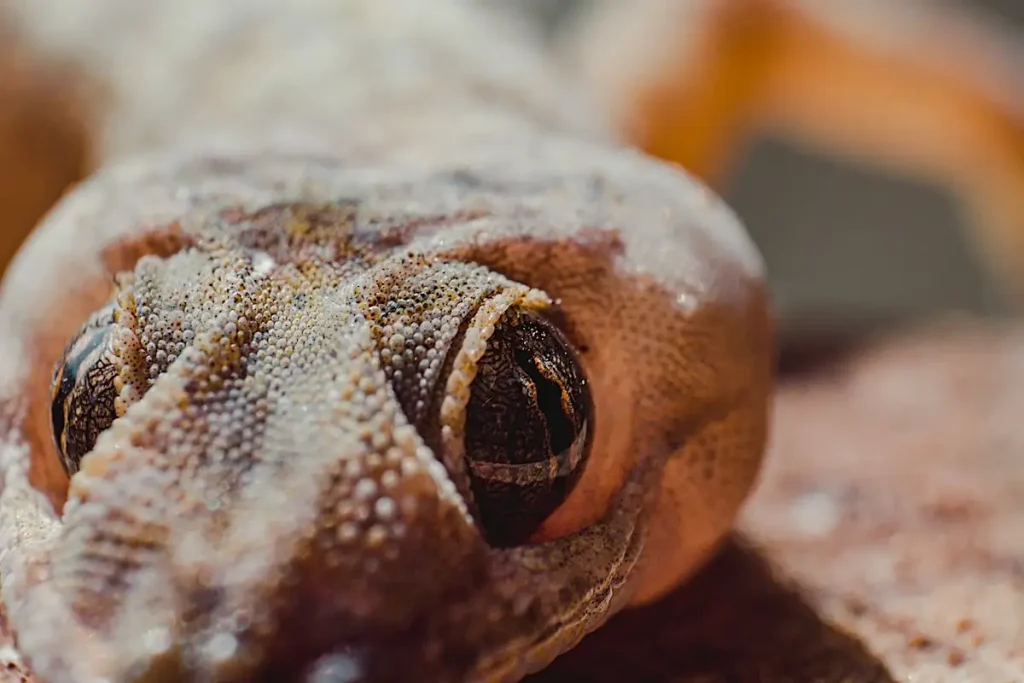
[50,305,117,476]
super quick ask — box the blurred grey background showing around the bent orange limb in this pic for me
[518,0,1024,335]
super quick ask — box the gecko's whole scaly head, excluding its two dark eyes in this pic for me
[0,127,771,681]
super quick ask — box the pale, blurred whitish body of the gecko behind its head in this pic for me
[8,0,612,166]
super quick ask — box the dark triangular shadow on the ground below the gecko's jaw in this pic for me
[527,539,894,683]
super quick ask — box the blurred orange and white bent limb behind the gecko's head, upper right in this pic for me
[572,0,1024,298]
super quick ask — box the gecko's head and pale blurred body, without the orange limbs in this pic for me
[0,0,773,683]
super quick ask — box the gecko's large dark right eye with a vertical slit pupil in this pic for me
[465,307,594,547]
